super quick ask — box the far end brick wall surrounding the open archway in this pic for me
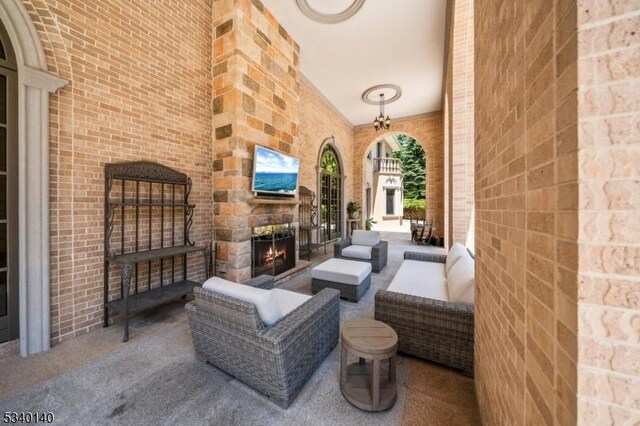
[352,113,444,237]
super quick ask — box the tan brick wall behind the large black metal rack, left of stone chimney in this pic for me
[23,0,212,343]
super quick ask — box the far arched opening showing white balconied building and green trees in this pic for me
[362,132,427,236]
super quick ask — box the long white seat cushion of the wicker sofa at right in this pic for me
[387,260,449,302]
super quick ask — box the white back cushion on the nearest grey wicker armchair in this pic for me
[202,277,284,325]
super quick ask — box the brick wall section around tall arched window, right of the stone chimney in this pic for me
[298,79,353,203]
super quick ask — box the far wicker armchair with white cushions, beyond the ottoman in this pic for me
[333,229,389,272]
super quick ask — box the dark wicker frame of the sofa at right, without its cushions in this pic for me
[375,252,474,377]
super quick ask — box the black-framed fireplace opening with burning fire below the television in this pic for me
[251,224,296,277]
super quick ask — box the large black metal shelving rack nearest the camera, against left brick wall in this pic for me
[104,161,211,342]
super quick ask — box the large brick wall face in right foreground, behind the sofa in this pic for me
[475,0,578,424]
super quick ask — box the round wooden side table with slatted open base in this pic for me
[340,319,398,411]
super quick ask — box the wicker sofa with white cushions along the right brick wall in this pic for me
[375,246,475,376]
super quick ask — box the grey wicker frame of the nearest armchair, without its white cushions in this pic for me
[186,276,340,408]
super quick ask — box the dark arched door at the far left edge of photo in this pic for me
[0,22,20,343]
